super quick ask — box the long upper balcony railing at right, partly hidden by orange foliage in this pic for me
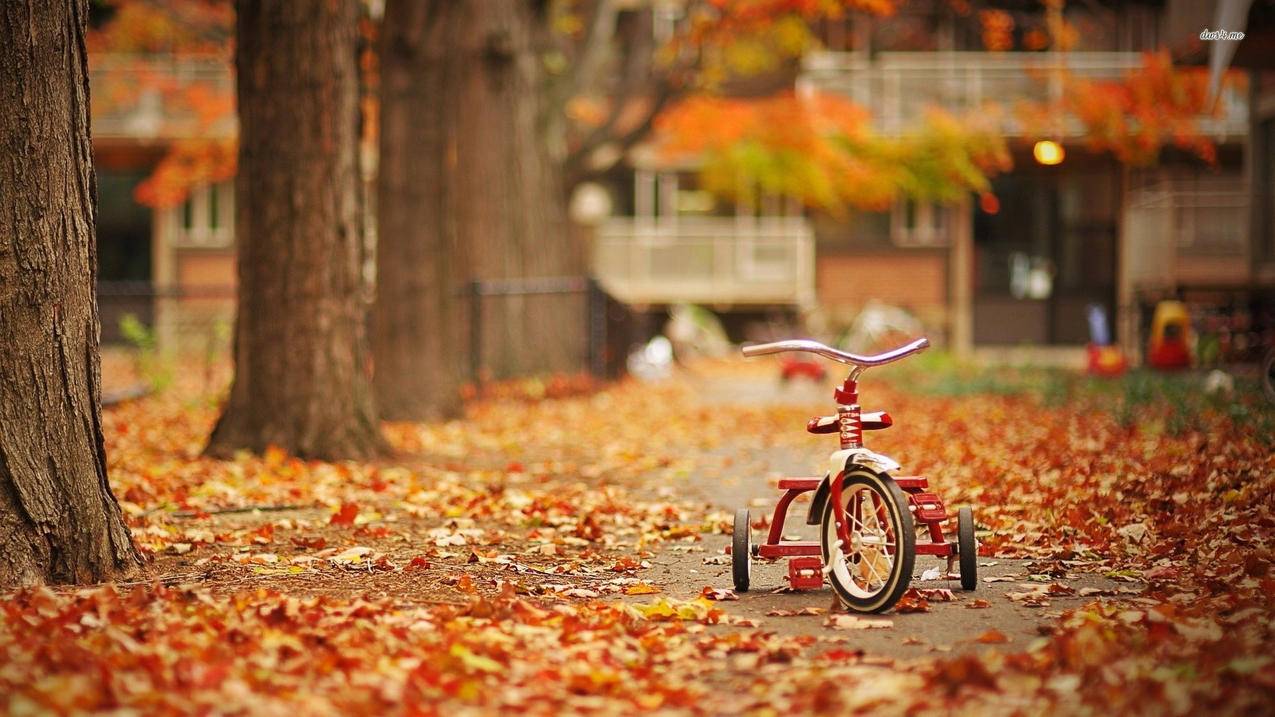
[799,51,1248,137]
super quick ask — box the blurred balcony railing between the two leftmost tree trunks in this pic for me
[89,54,236,140]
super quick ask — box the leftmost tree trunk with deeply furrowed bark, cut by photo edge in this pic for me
[0,0,140,587]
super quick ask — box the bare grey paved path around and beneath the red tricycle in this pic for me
[627,369,1141,658]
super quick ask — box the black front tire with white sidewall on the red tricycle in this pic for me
[819,467,917,612]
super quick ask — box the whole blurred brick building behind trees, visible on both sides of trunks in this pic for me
[92,0,1275,350]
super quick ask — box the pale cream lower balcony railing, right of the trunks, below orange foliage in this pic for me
[593,217,815,306]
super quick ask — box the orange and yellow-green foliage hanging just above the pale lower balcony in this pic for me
[657,92,1010,216]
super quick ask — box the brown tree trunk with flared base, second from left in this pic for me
[208,0,381,459]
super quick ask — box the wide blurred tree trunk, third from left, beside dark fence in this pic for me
[372,0,585,418]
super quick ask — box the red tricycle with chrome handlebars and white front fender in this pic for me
[731,338,978,612]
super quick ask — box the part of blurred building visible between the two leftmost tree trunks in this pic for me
[89,55,236,350]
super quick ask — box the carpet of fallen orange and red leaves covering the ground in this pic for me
[0,365,1275,714]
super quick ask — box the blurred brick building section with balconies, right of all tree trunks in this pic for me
[595,1,1257,350]
